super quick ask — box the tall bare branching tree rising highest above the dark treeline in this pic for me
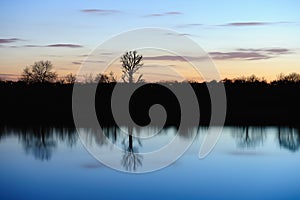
[121,51,144,83]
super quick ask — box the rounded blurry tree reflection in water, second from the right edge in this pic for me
[232,126,266,148]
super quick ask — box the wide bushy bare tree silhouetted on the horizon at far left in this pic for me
[20,60,57,83]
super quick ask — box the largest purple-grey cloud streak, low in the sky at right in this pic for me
[209,48,292,60]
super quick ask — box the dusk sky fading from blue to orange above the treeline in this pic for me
[0,0,300,81]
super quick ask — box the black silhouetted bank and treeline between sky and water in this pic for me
[0,73,300,125]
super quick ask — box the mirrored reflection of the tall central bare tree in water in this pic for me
[121,127,143,171]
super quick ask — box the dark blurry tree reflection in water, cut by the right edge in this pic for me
[278,127,300,152]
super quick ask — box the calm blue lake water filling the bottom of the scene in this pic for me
[0,127,300,199]
